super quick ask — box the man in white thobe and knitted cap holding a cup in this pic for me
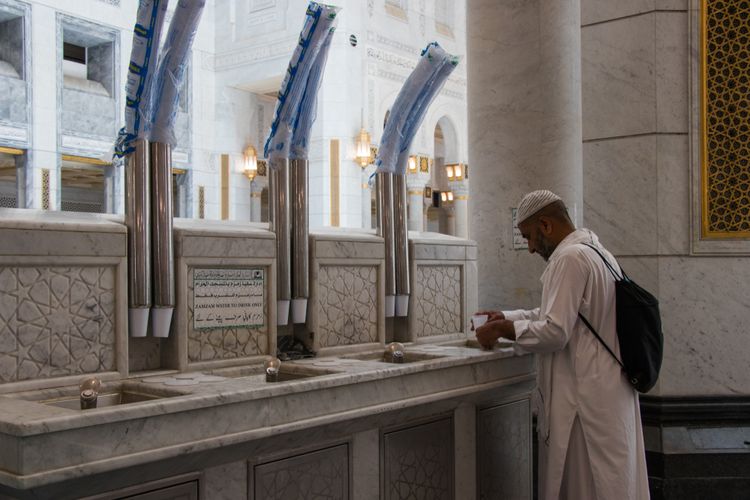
[476,190,649,500]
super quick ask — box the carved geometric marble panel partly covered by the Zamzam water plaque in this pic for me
[187,269,268,362]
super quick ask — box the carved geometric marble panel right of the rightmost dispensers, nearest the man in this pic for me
[412,265,463,337]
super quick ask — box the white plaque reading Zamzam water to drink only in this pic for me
[193,269,265,330]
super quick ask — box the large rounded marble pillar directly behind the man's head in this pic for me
[466,0,583,308]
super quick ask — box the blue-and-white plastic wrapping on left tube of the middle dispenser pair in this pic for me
[264,2,339,166]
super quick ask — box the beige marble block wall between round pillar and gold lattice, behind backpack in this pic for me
[581,0,750,395]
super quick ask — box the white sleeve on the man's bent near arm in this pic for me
[508,254,590,353]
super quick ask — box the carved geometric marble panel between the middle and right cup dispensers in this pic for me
[318,266,378,347]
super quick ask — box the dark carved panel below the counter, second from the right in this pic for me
[383,418,453,500]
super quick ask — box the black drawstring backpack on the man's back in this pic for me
[578,243,664,392]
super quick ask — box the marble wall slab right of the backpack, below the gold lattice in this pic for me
[657,257,750,396]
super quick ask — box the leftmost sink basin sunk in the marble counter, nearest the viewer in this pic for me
[9,382,185,411]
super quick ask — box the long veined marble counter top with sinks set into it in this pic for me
[0,344,534,489]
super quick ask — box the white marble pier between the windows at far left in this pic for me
[27,5,62,210]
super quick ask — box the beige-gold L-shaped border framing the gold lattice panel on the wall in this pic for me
[700,0,750,239]
